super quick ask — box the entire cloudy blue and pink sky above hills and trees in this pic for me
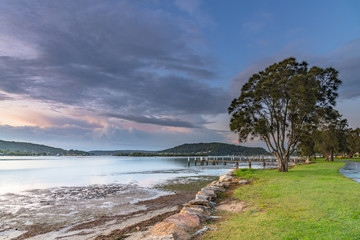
[0,0,360,150]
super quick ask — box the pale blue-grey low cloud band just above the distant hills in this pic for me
[0,125,227,150]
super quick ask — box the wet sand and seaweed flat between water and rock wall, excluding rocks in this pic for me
[0,177,217,240]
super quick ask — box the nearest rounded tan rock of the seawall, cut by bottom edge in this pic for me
[145,222,191,240]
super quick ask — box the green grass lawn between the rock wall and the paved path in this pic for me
[200,159,360,239]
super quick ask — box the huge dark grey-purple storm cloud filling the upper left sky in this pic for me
[0,0,228,127]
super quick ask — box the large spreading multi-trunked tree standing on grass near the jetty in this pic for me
[228,58,341,172]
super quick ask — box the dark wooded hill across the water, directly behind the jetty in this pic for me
[158,142,270,156]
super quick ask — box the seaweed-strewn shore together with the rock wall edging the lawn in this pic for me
[0,170,245,240]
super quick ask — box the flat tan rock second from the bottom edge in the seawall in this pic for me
[164,213,201,232]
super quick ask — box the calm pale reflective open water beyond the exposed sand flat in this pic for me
[0,156,245,194]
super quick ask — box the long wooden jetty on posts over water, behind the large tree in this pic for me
[187,156,305,168]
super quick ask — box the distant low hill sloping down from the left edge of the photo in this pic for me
[0,140,91,155]
